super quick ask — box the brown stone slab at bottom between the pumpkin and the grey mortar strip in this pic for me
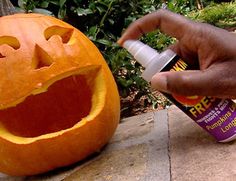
[65,144,148,181]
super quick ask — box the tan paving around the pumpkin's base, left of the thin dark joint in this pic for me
[0,110,170,181]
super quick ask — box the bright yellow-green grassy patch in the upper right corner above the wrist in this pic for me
[189,1,236,28]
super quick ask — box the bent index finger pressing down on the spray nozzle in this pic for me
[118,9,192,45]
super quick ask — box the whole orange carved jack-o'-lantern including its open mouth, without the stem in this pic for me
[0,14,120,175]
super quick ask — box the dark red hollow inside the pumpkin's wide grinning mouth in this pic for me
[0,70,96,137]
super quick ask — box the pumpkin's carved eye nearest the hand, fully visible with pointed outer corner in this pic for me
[44,26,74,43]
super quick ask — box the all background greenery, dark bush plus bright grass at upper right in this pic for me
[18,0,236,116]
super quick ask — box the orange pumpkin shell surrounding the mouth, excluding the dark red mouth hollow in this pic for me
[0,14,120,175]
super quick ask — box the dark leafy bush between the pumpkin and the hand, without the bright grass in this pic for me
[15,0,171,116]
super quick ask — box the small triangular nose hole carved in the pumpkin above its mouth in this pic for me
[32,44,53,69]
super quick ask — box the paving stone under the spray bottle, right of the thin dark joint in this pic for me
[168,106,236,181]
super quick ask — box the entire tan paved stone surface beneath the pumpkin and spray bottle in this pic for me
[0,106,236,181]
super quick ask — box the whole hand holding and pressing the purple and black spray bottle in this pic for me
[118,9,236,98]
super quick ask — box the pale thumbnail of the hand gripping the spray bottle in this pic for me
[151,74,169,93]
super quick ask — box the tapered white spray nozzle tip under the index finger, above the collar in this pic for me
[123,40,159,68]
